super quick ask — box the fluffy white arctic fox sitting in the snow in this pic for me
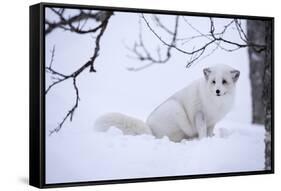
[95,64,240,142]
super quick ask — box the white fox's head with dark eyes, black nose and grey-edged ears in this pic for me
[203,65,240,97]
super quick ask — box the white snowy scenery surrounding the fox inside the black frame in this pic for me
[46,11,264,183]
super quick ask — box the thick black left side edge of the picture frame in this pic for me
[29,4,43,188]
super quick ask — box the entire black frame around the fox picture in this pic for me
[29,3,274,188]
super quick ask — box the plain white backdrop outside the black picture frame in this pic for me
[0,0,276,190]
